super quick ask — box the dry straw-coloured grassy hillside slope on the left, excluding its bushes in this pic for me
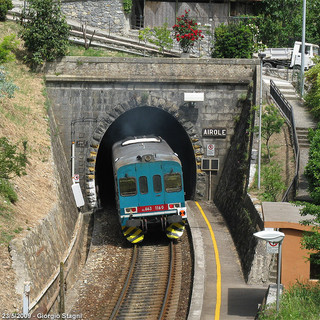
[0,22,57,312]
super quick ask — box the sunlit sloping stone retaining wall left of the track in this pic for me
[10,103,79,303]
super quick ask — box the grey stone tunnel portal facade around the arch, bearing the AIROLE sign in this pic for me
[46,57,259,207]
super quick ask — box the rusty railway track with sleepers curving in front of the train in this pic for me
[110,242,182,320]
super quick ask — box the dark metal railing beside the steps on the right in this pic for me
[270,80,300,202]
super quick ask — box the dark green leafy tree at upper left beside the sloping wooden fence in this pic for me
[21,0,70,66]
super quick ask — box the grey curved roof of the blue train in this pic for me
[112,136,181,170]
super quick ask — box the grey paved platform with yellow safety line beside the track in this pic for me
[188,201,267,320]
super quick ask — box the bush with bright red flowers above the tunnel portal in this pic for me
[172,10,204,52]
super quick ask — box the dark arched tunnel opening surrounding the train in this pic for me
[96,107,196,206]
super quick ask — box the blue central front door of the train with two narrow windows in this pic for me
[136,162,165,212]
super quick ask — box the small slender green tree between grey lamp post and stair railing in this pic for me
[261,105,284,162]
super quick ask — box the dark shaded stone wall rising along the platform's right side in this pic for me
[214,86,257,280]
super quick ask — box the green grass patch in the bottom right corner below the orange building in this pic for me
[259,282,320,320]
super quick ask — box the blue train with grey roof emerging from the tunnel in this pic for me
[112,136,187,244]
